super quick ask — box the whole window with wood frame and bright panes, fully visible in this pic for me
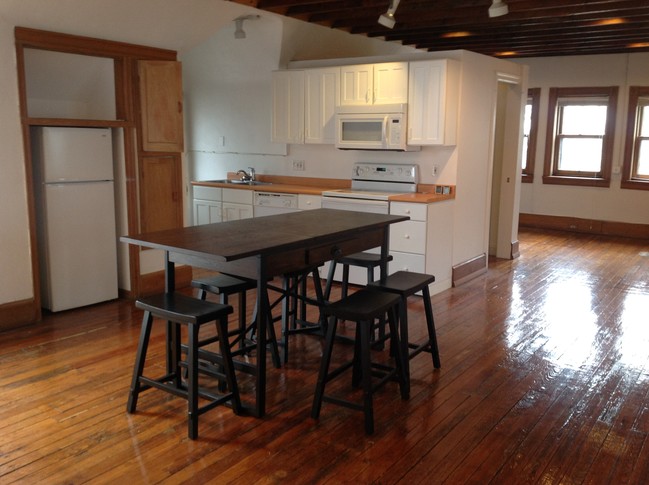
[543,86,618,187]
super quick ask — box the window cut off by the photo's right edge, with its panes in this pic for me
[621,86,649,190]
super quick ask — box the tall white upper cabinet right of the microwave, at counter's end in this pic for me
[408,59,460,145]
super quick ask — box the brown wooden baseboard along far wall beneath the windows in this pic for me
[519,213,649,239]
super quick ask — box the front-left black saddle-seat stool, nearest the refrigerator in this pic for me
[126,293,241,439]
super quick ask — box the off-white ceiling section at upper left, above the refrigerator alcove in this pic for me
[0,0,253,52]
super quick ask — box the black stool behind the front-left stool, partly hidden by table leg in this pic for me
[191,273,281,368]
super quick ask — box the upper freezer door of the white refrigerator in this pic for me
[36,127,114,183]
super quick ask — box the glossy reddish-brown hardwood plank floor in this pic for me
[0,231,649,485]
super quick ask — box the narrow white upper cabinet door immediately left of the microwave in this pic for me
[304,67,340,143]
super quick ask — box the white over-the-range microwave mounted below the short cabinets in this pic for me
[336,104,420,151]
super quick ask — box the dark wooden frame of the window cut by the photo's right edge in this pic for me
[620,86,649,190]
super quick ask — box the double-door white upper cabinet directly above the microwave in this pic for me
[340,62,408,106]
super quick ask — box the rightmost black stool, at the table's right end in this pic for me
[369,271,441,388]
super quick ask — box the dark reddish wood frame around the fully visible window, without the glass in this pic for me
[543,86,619,187]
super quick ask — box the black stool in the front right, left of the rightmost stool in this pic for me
[311,289,409,434]
